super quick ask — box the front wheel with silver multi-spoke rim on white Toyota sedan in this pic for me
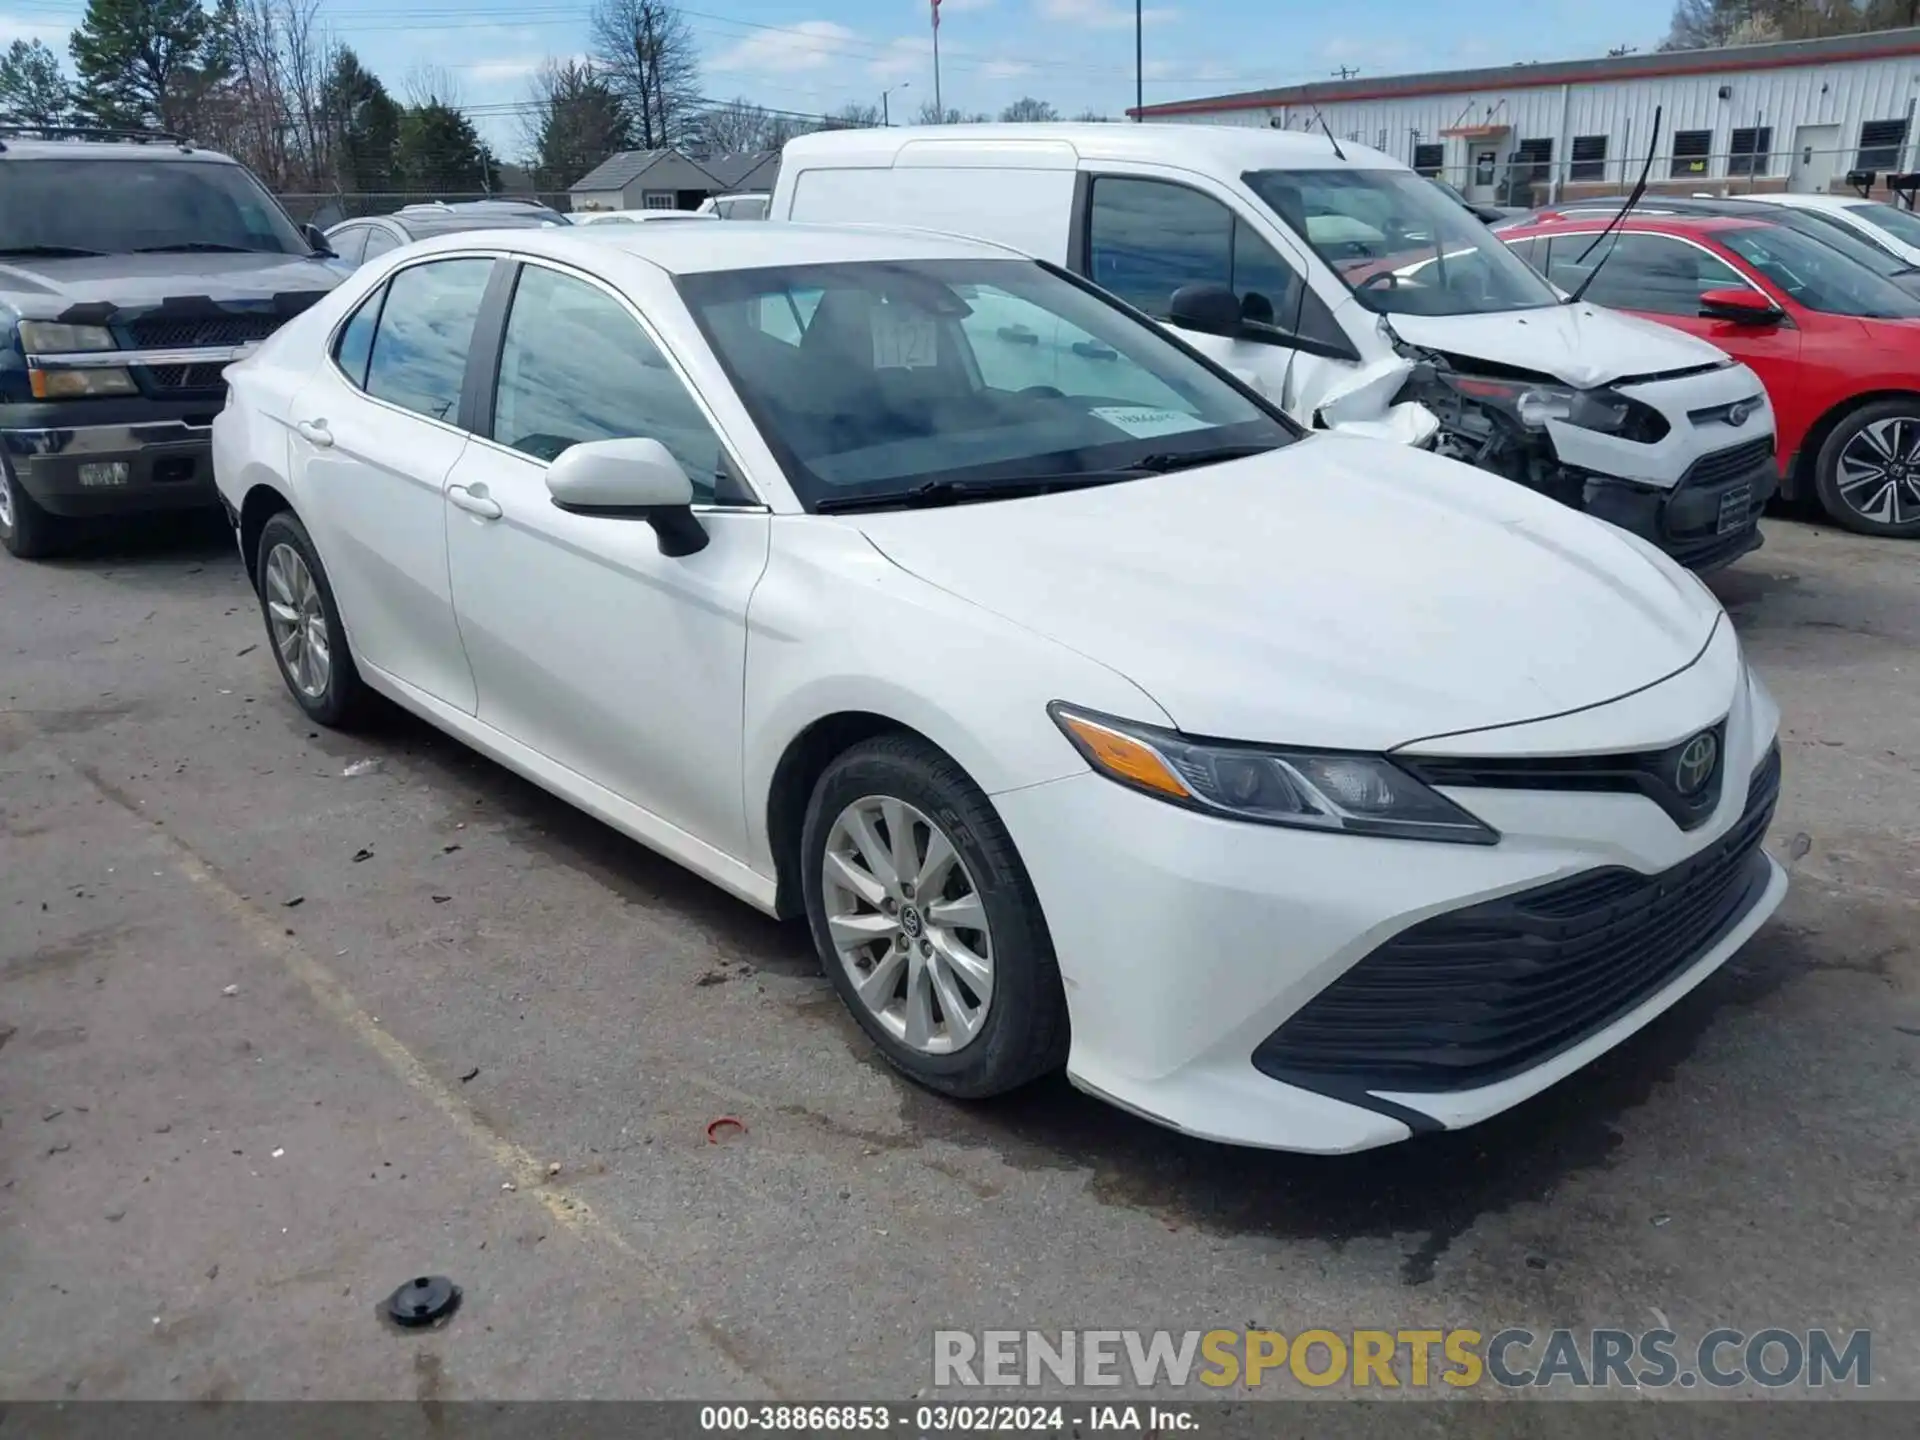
[801,735,1068,1096]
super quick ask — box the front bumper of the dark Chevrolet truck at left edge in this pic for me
[0,401,217,518]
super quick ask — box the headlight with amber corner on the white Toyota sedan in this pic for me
[1046,701,1500,845]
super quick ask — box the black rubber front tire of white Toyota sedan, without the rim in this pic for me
[801,735,1068,1098]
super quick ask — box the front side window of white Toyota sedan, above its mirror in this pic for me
[493,265,739,501]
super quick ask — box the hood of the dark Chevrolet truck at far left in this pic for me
[0,253,342,319]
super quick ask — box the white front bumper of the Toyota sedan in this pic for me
[995,648,1786,1152]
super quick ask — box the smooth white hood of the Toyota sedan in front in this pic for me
[843,436,1720,751]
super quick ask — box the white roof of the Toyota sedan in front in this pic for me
[395,221,1025,275]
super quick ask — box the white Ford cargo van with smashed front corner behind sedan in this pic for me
[768,125,1778,570]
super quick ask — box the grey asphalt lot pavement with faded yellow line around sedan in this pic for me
[0,506,1920,1400]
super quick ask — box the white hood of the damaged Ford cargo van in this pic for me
[1388,301,1726,388]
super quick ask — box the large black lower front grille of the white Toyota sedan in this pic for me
[1254,747,1780,1098]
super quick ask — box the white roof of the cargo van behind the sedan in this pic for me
[781,123,1407,173]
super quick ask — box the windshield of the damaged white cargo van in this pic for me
[1244,165,1559,315]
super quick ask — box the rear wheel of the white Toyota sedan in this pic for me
[255,511,371,726]
